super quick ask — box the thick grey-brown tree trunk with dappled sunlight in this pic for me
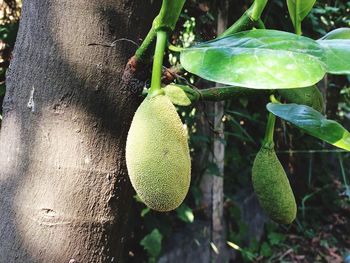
[0,0,155,263]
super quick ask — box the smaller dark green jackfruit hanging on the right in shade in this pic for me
[252,147,297,224]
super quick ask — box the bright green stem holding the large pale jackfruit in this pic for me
[149,30,167,96]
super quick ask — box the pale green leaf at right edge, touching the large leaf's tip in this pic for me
[317,39,350,74]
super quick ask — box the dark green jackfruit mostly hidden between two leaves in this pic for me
[278,85,324,112]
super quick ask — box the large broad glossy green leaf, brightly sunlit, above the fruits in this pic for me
[180,29,326,89]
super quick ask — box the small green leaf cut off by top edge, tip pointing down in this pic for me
[287,0,316,26]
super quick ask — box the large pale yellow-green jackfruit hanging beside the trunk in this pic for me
[126,95,191,212]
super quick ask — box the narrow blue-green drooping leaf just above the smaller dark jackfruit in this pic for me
[266,103,350,151]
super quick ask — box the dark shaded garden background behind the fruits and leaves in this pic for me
[0,0,350,263]
